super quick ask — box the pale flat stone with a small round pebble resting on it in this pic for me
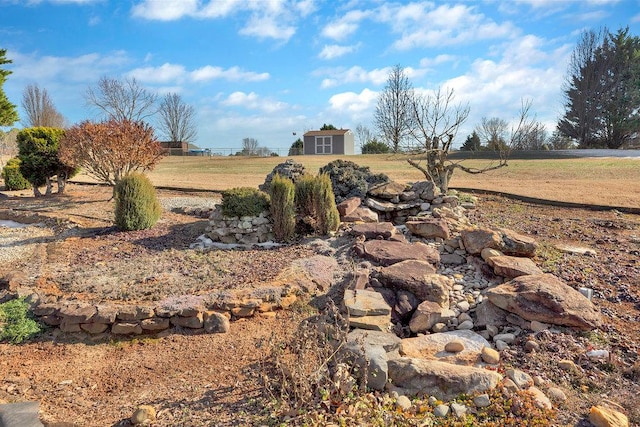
[400,330,491,365]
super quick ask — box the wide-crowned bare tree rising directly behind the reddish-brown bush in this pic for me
[84,77,158,122]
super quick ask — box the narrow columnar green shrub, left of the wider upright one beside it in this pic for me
[271,175,296,242]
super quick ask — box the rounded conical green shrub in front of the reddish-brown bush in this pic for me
[114,172,162,231]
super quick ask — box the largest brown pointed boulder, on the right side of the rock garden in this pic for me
[487,274,602,330]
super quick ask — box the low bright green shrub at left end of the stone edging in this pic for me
[0,298,42,344]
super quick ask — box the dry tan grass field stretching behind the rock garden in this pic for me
[140,155,640,207]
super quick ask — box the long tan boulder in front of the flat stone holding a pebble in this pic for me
[388,357,502,401]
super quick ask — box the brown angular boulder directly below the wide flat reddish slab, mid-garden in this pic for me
[378,260,453,308]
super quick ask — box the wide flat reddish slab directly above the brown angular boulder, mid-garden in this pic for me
[356,240,440,266]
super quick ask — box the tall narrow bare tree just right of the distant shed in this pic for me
[373,65,413,153]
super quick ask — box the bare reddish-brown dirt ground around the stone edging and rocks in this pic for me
[0,185,640,426]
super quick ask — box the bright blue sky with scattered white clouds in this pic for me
[0,0,640,154]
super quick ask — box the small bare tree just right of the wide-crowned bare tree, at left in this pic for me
[158,93,197,142]
